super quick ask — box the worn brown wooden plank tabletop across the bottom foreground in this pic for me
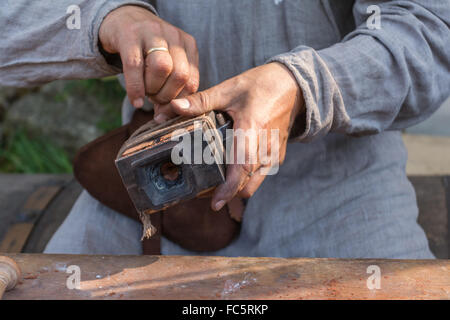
[4,254,450,299]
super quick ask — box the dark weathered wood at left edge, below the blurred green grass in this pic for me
[0,174,81,252]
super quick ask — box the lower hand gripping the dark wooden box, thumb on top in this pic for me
[163,63,304,210]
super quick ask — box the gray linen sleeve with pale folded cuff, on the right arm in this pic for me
[268,0,450,142]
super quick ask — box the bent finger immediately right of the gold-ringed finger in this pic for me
[151,45,190,104]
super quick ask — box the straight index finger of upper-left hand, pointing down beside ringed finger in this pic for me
[120,40,145,108]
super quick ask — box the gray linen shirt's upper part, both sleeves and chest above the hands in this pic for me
[0,0,450,141]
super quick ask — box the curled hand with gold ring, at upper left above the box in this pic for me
[99,6,199,115]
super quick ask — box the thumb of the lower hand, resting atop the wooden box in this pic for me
[170,85,230,117]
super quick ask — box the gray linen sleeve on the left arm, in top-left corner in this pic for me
[0,0,156,87]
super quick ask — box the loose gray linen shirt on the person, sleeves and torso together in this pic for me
[0,0,450,257]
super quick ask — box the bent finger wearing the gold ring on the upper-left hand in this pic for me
[145,39,173,96]
